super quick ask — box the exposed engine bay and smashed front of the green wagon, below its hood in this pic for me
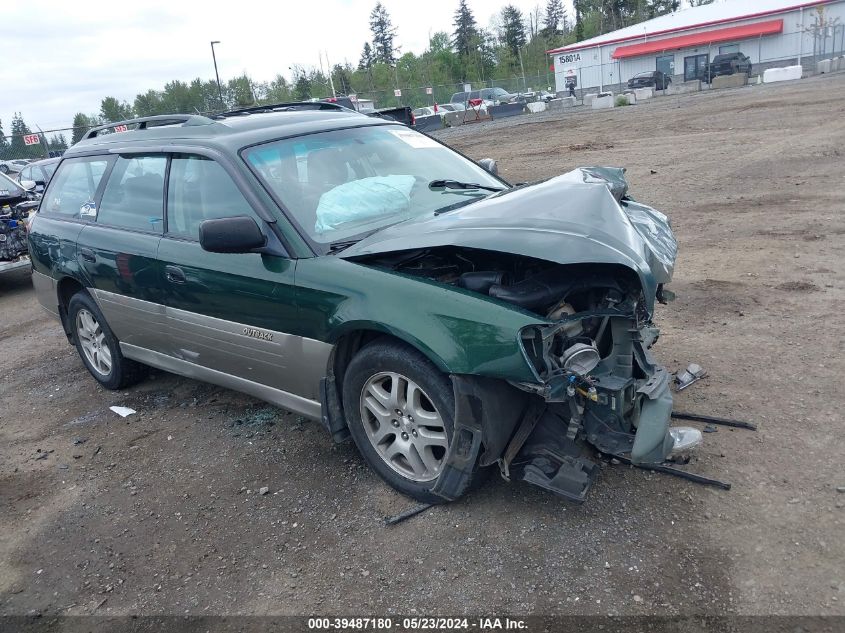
[356,246,674,501]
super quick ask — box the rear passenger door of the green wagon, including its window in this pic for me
[77,154,167,352]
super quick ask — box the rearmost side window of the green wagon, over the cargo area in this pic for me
[41,156,109,220]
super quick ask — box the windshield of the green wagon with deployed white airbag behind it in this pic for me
[244,125,506,247]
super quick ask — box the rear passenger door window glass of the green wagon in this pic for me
[97,156,167,232]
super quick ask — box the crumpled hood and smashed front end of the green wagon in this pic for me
[342,168,701,502]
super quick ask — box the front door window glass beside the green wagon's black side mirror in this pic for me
[167,155,259,240]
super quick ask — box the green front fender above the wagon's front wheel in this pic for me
[296,257,543,382]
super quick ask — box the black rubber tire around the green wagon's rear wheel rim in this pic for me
[67,290,148,390]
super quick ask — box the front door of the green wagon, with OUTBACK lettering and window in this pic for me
[158,154,322,402]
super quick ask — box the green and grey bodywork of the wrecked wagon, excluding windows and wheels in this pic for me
[29,108,700,500]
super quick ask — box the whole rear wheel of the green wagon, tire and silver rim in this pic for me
[67,290,147,390]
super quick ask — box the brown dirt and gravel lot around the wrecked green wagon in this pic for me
[0,74,845,615]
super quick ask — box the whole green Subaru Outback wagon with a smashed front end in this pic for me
[29,104,700,502]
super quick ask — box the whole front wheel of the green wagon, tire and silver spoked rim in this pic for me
[343,341,474,503]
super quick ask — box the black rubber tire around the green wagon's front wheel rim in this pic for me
[343,339,486,503]
